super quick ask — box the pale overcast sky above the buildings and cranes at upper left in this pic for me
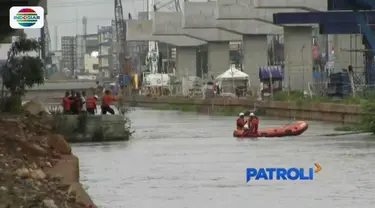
[0,0,197,59]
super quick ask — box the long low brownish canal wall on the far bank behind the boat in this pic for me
[128,96,361,123]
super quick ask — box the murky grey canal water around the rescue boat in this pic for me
[73,109,375,208]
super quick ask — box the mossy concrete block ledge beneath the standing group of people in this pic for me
[55,115,129,142]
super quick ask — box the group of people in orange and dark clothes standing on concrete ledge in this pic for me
[61,90,118,115]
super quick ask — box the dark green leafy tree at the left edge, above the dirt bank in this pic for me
[1,33,44,112]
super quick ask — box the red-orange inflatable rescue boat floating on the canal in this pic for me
[233,121,308,138]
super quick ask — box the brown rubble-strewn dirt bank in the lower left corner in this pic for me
[0,116,95,208]
